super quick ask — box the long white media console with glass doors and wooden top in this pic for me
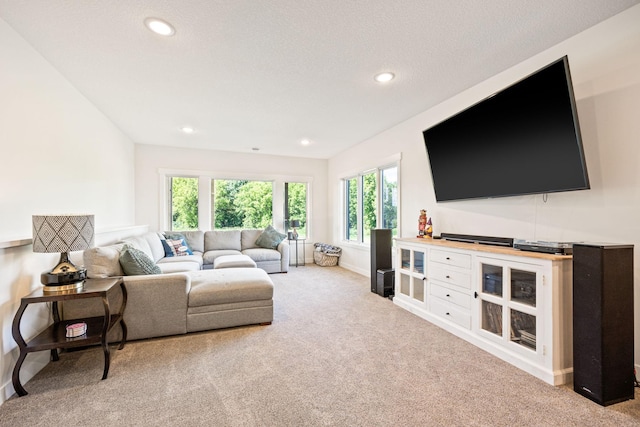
[393,238,573,385]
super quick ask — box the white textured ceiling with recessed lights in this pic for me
[0,0,640,158]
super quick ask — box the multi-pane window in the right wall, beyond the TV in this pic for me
[343,165,398,243]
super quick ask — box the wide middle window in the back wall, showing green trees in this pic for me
[211,179,273,229]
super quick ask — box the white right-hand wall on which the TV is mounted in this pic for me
[328,6,640,364]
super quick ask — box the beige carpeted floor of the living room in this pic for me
[0,265,640,426]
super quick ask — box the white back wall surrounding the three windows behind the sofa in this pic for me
[135,144,328,258]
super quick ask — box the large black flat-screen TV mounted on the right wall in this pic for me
[423,56,589,202]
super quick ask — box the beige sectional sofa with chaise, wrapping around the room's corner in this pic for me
[62,230,289,341]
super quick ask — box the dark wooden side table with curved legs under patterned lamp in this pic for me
[11,277,127,396]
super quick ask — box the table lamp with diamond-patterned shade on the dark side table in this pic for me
[33,215,94,292]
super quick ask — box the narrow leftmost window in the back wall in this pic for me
[170,176,198,230]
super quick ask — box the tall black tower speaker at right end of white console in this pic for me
[573,244,635,406]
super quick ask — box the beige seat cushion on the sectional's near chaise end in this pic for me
[188,268,273,307]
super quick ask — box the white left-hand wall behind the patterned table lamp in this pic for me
[0,19,134,402]
